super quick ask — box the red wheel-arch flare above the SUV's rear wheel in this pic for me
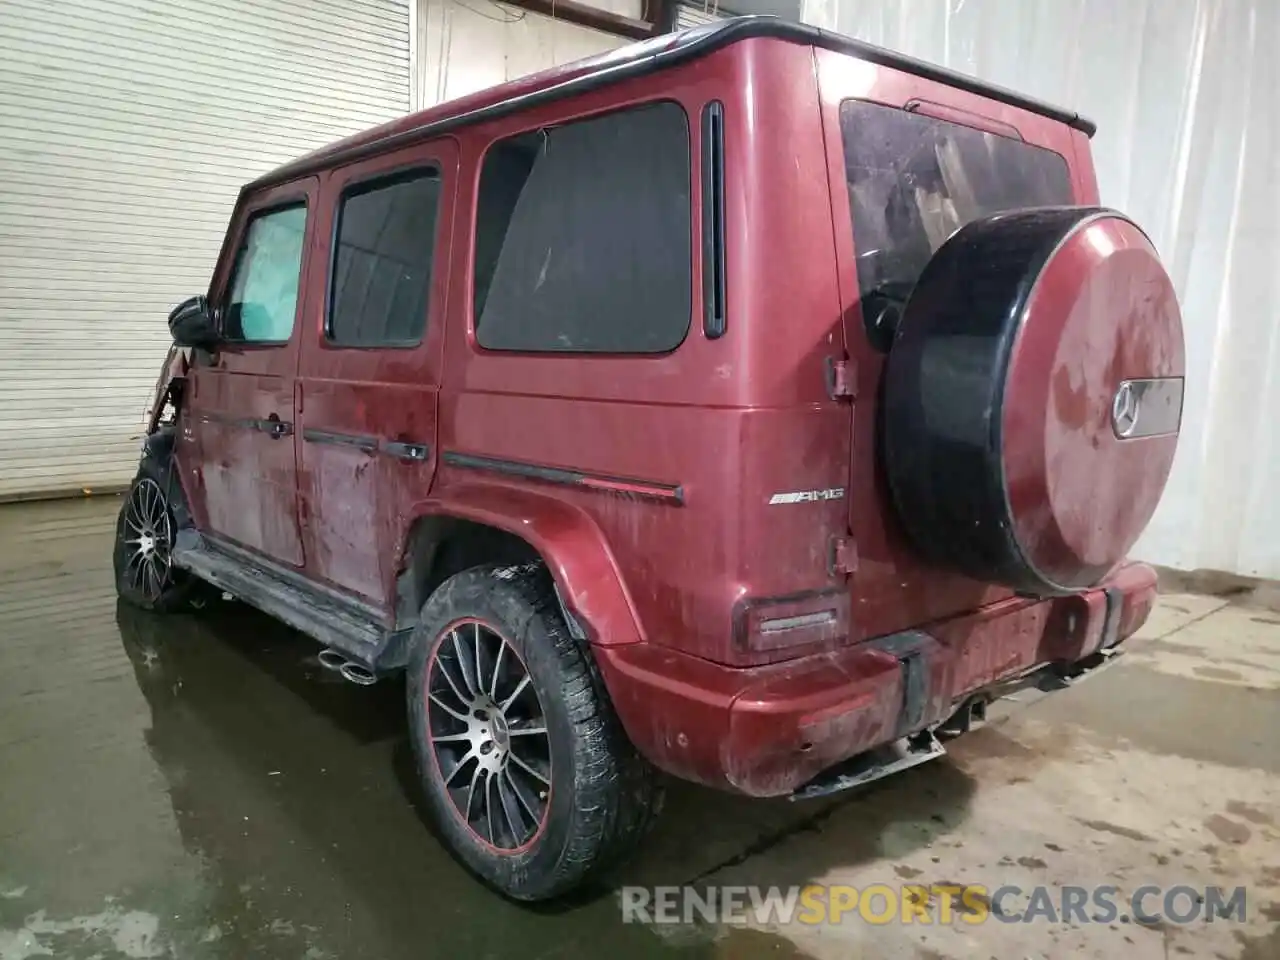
[411,481,645,646]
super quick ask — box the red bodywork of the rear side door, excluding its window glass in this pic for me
[297,140,457,609]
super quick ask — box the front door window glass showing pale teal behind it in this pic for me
[223,204,307,343]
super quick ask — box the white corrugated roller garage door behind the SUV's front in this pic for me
[0,0,410,499]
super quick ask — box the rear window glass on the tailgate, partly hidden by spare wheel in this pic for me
[840,100,1073,349]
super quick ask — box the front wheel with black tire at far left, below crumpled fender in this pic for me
[113,444,201,613]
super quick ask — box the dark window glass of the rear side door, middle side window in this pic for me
[325,169,440,347]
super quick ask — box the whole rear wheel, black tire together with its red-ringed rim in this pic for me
[407,563,662,901]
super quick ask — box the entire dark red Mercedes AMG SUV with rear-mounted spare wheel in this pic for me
[115,18,1184,900]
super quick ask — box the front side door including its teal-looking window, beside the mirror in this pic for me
[179,178,319,567]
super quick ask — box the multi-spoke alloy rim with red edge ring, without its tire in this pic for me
[426,620,552,851]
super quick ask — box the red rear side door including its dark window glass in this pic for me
[298,140,457,604]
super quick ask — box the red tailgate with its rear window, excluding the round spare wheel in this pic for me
[815,50,1079,637]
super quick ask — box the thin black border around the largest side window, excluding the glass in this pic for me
[465,93,701,360]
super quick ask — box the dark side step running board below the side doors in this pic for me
[173,529,398,672]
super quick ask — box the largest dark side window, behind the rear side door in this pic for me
[475,102,692,353]
